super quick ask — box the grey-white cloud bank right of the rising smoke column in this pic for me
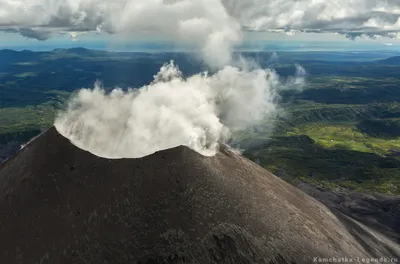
[230,0,400,33]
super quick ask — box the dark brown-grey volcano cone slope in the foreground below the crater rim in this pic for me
[0,128,394,264]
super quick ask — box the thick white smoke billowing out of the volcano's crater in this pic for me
[55,62,296,158]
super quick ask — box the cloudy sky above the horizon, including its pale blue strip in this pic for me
[0,0,400,53]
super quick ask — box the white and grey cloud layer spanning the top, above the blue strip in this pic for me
[0,0,400,41]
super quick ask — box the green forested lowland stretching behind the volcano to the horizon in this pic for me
[0,49,400,194]
